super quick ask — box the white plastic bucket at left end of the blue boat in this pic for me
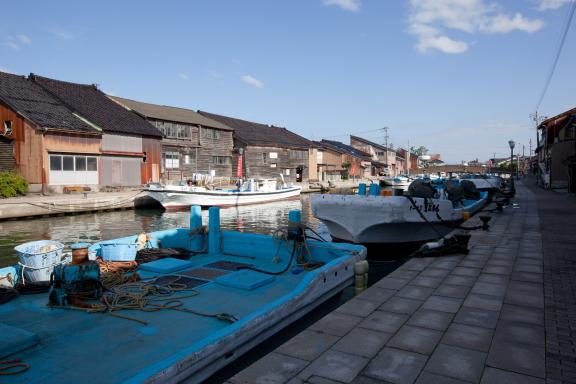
[14,240,64,282]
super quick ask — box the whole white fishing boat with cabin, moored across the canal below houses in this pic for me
[145,179,302,209]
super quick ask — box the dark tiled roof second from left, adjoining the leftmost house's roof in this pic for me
[30,75,162,137]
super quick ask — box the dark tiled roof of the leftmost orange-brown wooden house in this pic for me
[0,72,99,133]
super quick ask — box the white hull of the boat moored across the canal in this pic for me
[146,187,301,210]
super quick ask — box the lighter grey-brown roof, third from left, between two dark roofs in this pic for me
[108,96,232,131]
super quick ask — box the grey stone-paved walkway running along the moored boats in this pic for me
[229,184,560,384]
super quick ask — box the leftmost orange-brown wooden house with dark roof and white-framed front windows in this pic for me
[0,72,102,192]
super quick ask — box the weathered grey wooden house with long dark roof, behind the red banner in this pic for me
[198,111,316,182]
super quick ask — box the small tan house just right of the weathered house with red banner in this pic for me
[316,139,371,180]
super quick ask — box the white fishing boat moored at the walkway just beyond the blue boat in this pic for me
[311,179,488,244]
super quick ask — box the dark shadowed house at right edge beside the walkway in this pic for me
[536,108,576,192]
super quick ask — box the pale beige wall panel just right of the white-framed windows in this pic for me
[100,156,142,187]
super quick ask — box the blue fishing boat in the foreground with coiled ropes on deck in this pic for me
[0,206,366,383]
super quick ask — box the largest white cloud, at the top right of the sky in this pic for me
[408,0,544,54]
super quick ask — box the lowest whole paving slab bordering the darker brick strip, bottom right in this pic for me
[486,340,546,378]
